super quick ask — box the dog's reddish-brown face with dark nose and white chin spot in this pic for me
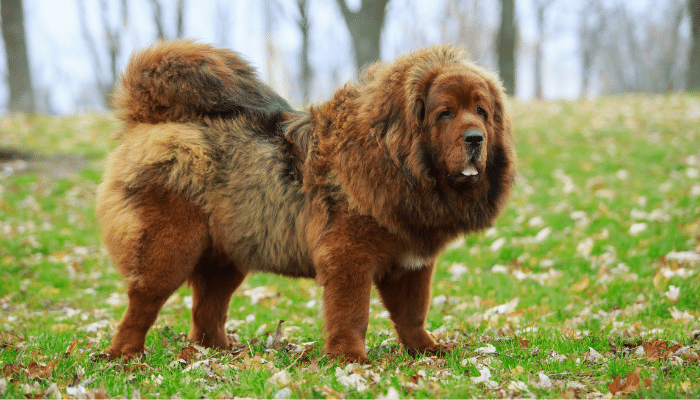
[424,68,498,190]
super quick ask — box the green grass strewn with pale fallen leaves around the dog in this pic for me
[0,95,700,398]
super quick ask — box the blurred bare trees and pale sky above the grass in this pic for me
[0,0,700,114]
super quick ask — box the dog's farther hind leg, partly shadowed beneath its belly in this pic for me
[189,257,245,348]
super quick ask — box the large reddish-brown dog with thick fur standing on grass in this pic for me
[97,41,515,361]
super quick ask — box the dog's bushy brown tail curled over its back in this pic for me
[113,40,293,123]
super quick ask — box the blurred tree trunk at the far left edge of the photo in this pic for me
[0,0,34,112]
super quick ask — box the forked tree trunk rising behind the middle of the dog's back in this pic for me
[336,0,392,71]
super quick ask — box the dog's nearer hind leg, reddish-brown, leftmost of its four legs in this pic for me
[103,189,210,358]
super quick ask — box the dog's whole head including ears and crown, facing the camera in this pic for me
[411,47,514,191]
